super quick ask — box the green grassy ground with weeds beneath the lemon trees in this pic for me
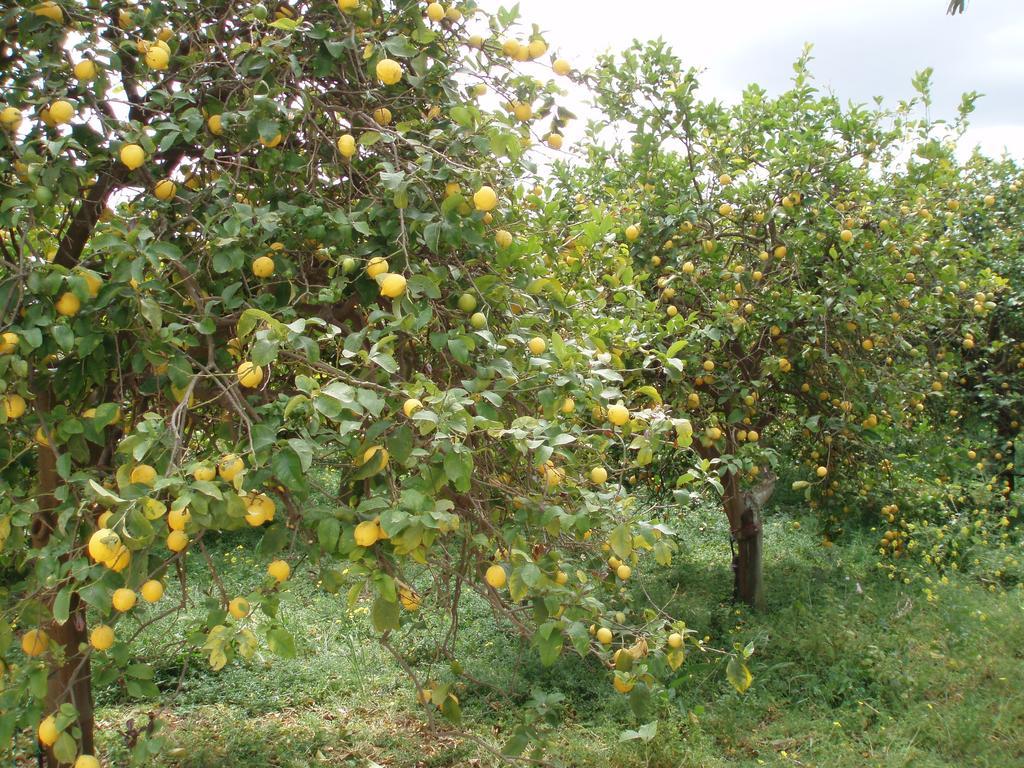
[81,505,1024,768]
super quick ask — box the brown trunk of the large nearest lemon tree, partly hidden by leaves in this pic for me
[32,391,94,768]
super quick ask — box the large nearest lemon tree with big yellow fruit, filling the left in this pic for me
[0,0,696,765]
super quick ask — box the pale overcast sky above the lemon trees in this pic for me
[481,0,1024,158]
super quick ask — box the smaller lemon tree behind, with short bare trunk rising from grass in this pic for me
[546,43,1004,605]
